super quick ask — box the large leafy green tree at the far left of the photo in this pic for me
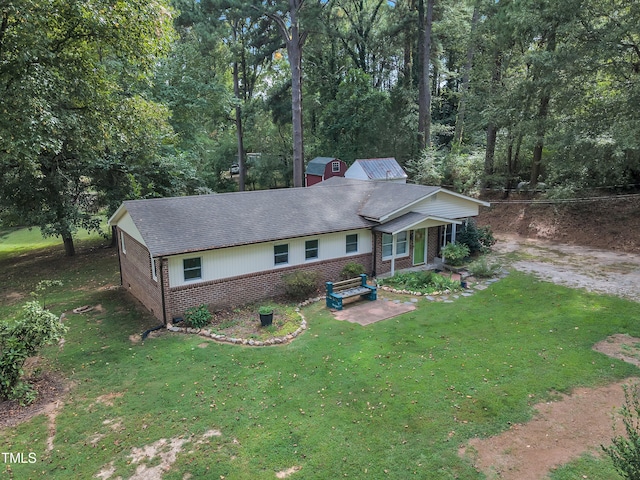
[0,0,171,255]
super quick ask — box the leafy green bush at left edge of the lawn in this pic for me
[0,301,67,404]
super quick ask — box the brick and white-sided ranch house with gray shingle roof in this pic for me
[109,177,489,323]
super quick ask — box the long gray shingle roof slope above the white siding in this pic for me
[124,186,373,257]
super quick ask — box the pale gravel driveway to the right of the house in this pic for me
[493,235,640,302]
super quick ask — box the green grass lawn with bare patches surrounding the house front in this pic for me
[0,227,640,480]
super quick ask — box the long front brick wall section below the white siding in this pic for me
[163,254,372,321]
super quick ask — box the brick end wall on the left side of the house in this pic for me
[117,229,163,320]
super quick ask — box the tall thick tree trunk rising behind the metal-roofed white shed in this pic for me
[418,0,435,148]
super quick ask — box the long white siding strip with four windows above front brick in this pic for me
[169,229,372,287]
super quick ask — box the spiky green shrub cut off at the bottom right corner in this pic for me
[601,383,640,480]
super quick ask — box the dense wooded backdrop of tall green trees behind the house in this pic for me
[0,0,640,254]
